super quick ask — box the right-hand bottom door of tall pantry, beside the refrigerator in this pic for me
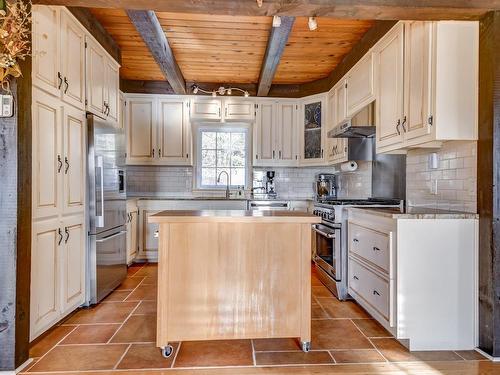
[61,215,86,314]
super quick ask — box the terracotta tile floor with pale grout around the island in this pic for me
[26,264,486,374]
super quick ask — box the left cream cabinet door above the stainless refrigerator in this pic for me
[86,38,106,116]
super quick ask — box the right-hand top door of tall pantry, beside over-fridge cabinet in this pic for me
[61,10,85,110]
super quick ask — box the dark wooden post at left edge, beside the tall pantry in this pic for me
[0,59,31,371]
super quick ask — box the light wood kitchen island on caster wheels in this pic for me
[149,210,321,356]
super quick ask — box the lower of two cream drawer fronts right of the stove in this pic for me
[349,258,390,321]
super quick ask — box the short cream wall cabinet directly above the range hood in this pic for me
[346,52,375,116]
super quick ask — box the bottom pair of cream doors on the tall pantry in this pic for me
[30,214,87,340]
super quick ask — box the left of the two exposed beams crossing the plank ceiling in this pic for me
[127,10,186,94]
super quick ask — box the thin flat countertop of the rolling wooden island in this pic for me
[148,210,321,224]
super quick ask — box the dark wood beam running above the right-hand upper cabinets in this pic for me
[300,21,396,96]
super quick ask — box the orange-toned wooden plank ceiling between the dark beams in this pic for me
[91,8,374,84]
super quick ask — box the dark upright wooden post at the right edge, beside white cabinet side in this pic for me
[477,12,500,357]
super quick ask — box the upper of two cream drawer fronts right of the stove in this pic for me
[349,223,391,273]
